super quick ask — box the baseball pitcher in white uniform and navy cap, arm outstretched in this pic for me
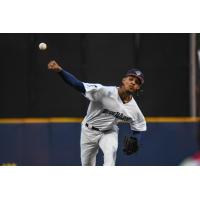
[48,60,146,166]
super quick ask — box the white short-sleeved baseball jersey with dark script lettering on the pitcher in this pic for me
[82,83,146,131]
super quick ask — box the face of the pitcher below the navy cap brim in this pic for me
[122,76,141,93]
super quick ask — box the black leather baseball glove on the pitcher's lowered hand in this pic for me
[123,136,139,155]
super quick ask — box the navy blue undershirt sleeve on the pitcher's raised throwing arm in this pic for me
[58,69,85,94]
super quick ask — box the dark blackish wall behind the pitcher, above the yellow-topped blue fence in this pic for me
[0,33,189,118]
